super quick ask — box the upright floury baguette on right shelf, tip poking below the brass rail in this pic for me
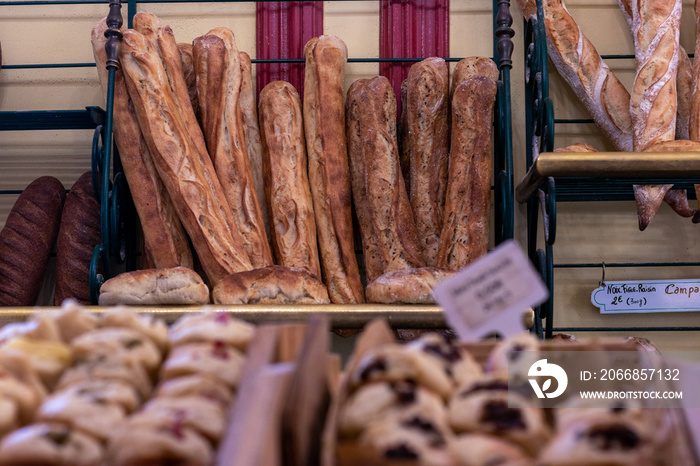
[630,0,681,230]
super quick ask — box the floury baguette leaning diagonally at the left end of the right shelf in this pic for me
[536,0,633,152]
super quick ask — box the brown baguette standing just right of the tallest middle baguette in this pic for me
[345,76,424,281]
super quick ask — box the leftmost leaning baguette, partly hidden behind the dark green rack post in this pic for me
[92,19,193,267]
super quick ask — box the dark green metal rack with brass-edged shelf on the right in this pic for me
[515,0,700,338]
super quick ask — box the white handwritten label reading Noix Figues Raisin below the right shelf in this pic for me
[591,280,700,314]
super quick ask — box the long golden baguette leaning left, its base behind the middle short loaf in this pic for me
[193,28,272,268]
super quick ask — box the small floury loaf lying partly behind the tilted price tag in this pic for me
[367,267,455,304]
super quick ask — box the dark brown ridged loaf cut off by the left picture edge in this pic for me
[0,176,66,306]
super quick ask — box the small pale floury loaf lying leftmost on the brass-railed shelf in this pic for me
[100,267,209,306]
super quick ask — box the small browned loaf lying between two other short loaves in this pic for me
[212,265,330,304]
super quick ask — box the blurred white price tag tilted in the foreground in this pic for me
[433,241,549,341]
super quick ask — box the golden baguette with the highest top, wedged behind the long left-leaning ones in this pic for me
[134,12,207,160]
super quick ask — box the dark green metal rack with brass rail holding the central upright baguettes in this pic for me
[0,0,514,328]
